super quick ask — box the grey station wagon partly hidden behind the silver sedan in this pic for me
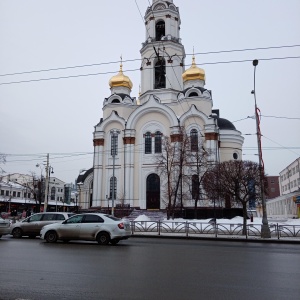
[11,212,74,238]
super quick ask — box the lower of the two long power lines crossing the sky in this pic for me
[0,56,300,85]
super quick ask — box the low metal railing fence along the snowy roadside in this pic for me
[131,221,300,241]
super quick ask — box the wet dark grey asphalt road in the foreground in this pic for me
[0,236,300,300]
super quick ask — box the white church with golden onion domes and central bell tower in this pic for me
[77,0,244,209]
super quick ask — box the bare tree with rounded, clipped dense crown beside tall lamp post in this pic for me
[203,160,260,235]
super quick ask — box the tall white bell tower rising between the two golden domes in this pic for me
[140,0,185,103]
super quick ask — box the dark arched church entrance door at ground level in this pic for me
[146,174,160,209]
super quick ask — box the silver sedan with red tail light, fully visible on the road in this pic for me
[40,213,131,245]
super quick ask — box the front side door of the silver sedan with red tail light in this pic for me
[57,215,83,240]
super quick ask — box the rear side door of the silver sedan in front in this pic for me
[79,214,104,240]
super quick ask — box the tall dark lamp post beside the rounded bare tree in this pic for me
[251,59,271,238]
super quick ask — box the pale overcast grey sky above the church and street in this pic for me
[0,0,300,183]
